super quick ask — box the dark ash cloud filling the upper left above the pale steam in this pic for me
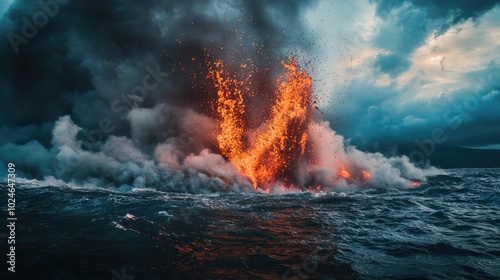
[0,0,316,141]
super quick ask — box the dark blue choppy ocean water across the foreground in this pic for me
[0,169,500,280]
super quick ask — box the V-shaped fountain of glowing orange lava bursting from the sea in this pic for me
[209,58,312,189]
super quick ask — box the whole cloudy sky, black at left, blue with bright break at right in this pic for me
[0,0,500,178]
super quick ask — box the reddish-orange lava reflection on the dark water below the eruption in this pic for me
[168,206,334,279]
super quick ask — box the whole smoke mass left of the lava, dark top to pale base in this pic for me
[0,0,314,192]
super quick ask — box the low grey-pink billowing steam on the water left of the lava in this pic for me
[18,108,254,192]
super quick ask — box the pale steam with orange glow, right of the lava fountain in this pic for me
[302,121,442,189]
